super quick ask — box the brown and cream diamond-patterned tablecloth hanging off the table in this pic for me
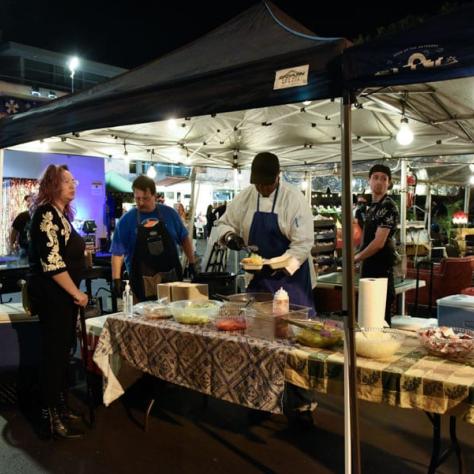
[90,315,288,413]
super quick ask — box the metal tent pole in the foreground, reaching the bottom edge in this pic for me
[341,90,360,474]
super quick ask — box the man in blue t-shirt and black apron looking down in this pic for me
[110,176,195,301]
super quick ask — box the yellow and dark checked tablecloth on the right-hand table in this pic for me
[285,336,474,424]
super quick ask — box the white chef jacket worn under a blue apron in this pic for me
[215,181,314,267]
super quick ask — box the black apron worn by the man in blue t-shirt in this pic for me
[130,207,183,301]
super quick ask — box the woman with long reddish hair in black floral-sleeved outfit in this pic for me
[28,165,88,439]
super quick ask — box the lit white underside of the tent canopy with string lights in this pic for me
[6,78,474,181]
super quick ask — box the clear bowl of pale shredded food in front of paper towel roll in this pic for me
[355,328,405,359]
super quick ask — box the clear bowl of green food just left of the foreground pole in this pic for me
[290,319,344,348]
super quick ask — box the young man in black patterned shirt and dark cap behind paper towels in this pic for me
[354,164,399,324]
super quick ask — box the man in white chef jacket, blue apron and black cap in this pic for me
[216,152,316,427]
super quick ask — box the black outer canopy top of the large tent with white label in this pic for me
[0,2,350,148]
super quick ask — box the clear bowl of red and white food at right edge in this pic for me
[418,326,474,360]
